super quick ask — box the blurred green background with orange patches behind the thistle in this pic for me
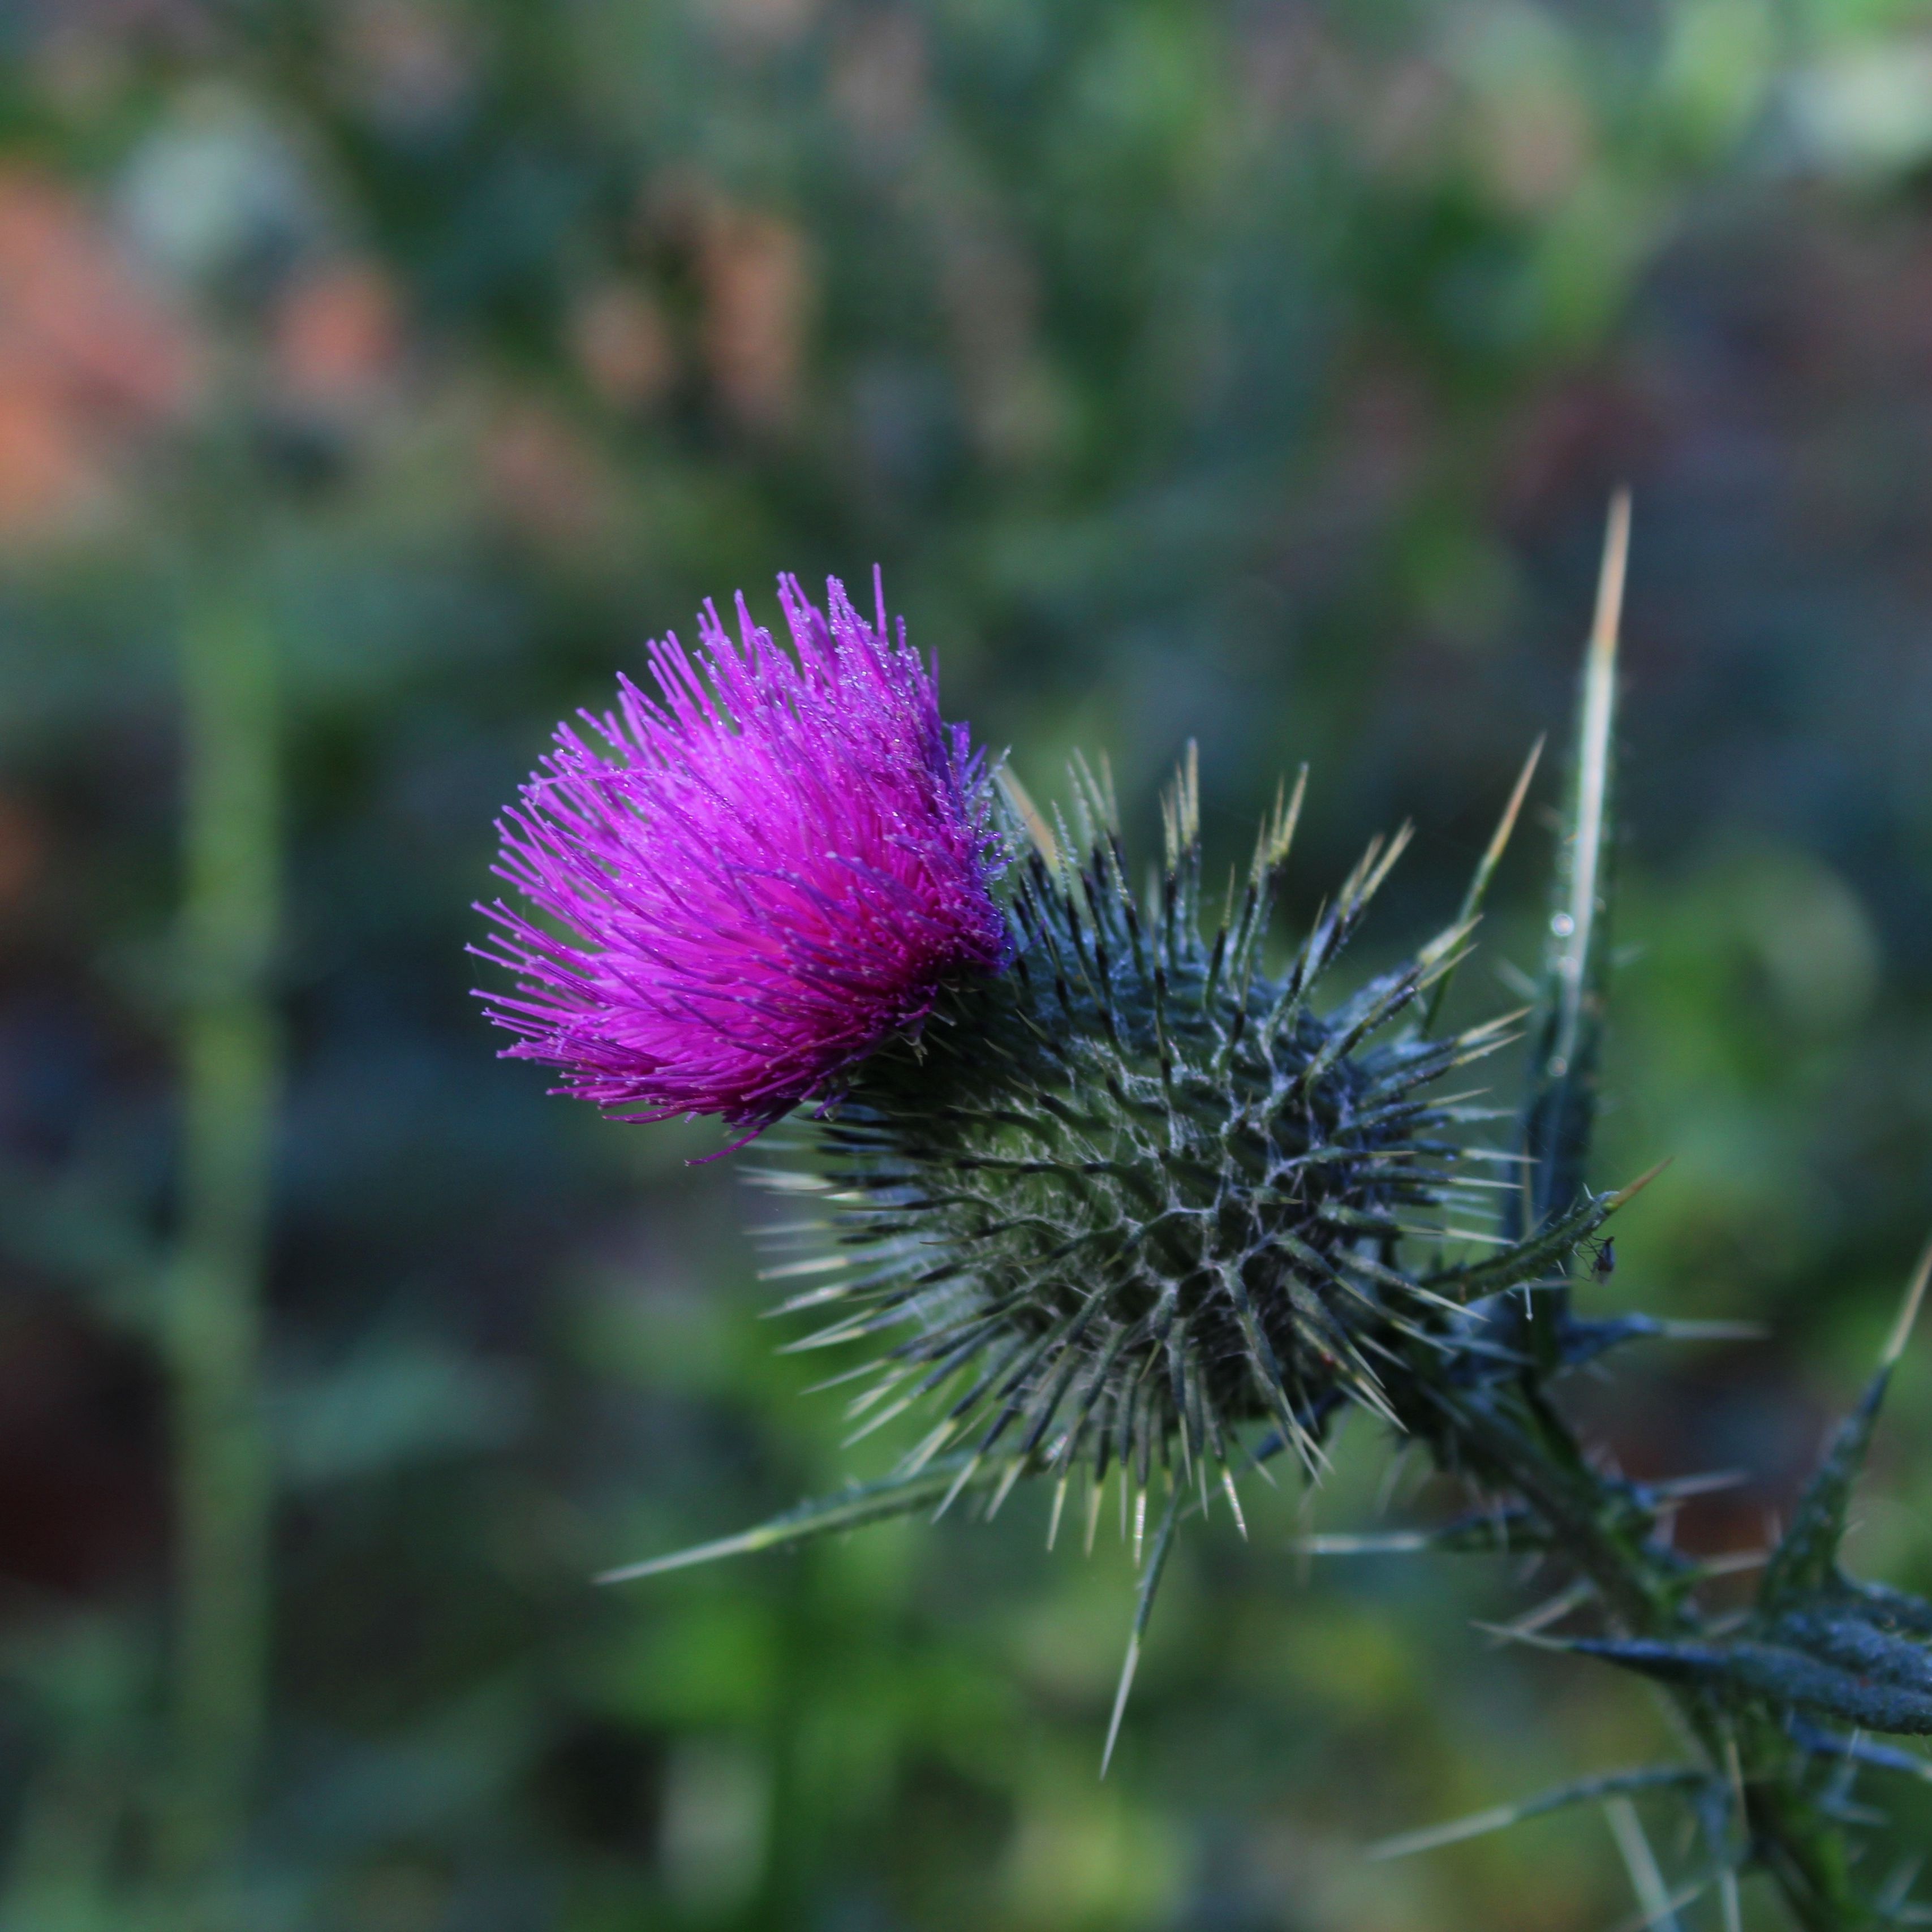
[0,0,1932,1932]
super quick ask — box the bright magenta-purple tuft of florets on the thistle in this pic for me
[477,576,1006,1138]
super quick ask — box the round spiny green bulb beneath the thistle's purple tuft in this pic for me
[759,754,1568,1542]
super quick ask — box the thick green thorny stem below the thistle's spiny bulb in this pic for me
[1430,1382,1882,1932]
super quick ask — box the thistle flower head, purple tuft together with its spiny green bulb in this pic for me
[514,578,1610,1544]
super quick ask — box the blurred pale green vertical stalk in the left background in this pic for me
[162,568,282,1890]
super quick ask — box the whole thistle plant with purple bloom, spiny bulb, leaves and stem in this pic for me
[471,518,1932,1932]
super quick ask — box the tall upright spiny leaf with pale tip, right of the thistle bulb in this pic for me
[1505,490,1630,1238]
